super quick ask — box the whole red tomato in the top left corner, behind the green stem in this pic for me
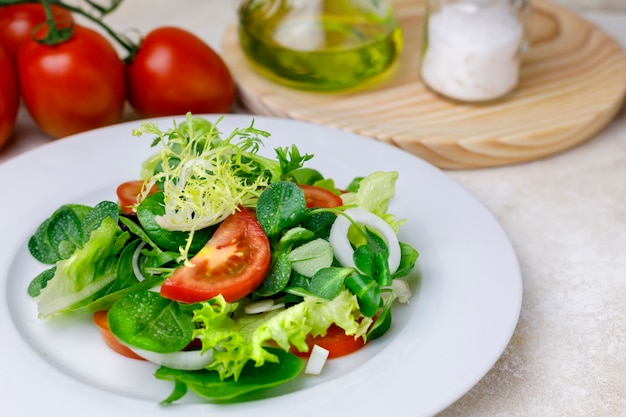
[0,3,74,61]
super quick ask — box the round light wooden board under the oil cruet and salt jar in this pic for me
[222,0,626,169]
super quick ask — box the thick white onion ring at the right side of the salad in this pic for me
[328,208,401,274]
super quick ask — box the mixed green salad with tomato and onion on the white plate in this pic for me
[28,114,418,403]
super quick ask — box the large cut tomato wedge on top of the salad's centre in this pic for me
[161,209,270,303]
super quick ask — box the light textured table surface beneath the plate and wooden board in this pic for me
[0,0,626,417]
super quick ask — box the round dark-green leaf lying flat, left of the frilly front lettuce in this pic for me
[108,290,195,353]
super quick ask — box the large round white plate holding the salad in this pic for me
[0,115,522,417]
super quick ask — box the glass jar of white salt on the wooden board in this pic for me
[420,0,529,102]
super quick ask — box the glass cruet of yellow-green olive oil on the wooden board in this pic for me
[238,0,402,91]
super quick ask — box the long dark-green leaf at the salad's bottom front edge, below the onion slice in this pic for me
[155,347,304,404]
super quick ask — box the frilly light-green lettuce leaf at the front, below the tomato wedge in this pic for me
[194,291,371,380]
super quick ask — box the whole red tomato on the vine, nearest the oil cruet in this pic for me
[126,27,235,117]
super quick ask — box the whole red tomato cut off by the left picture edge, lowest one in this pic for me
[0,45,20,148]
